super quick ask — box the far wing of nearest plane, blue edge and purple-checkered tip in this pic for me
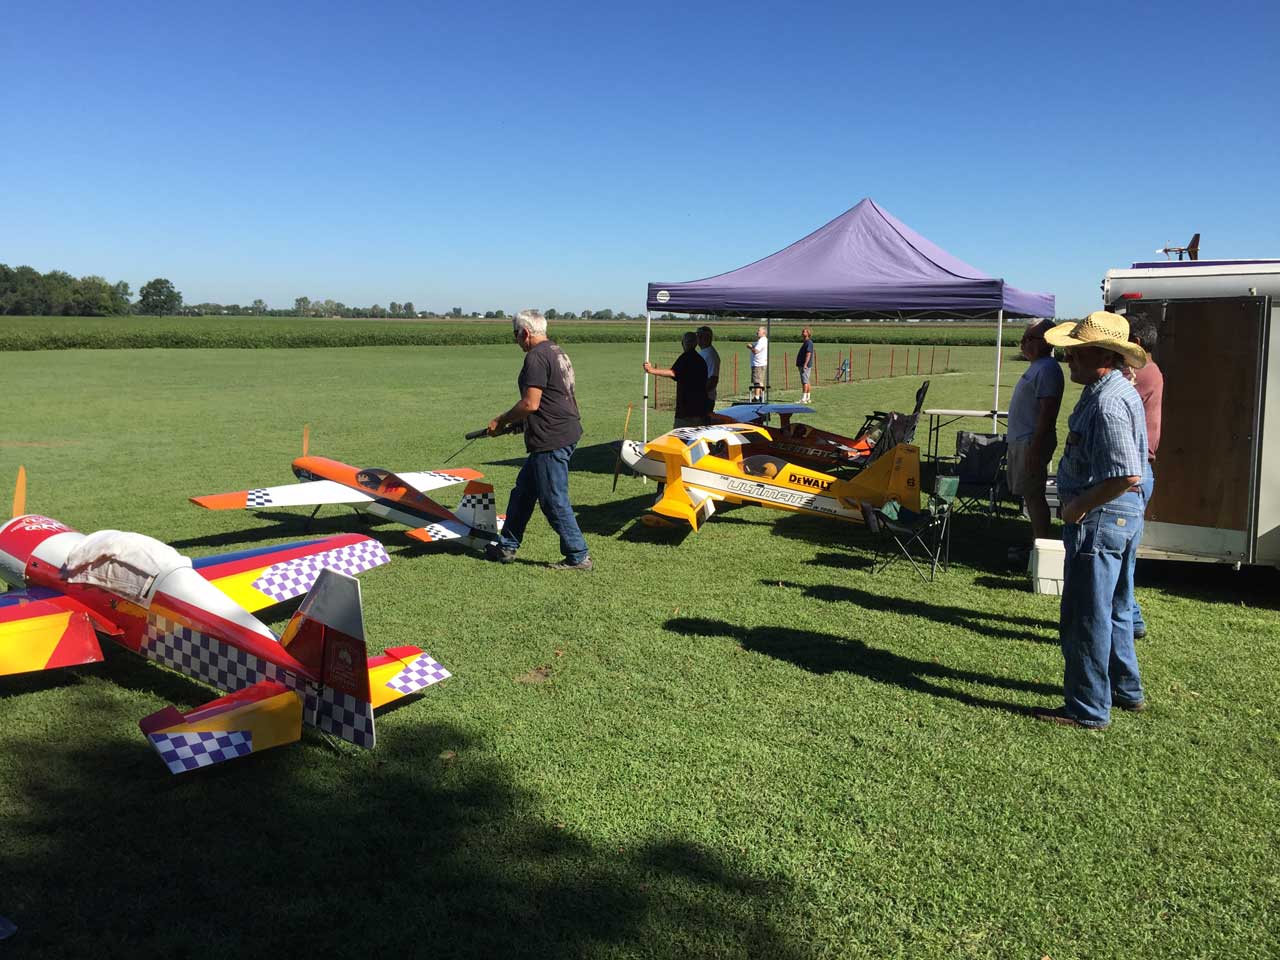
[192,534,390,613]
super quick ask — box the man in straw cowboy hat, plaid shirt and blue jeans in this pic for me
[1036,311,1147,730]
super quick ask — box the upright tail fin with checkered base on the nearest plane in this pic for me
[280,567,375,749]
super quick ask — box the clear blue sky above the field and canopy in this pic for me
[0,0,1280,316]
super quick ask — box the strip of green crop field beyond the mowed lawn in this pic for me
[0,316,1021,351]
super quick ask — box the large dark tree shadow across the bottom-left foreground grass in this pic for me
[0,687,806,960]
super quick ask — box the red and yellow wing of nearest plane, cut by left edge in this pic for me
[0,586,104,676]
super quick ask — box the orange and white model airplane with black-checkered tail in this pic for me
[191,431,502,548]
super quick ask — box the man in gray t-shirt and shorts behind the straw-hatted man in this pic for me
[1006,320,1065,547]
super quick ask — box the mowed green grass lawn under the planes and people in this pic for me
[0,344,1280,960]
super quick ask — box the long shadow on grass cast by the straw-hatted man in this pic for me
[663,617,1061,716]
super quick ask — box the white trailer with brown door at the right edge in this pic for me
[1102,260,1280,567]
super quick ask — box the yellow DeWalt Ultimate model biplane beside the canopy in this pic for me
[622,424,920,531]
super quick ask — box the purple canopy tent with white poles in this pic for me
[644,197,1053,438]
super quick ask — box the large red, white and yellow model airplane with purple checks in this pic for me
[0,471,449,773]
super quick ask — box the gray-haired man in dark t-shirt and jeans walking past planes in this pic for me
[485,310,593,571]
